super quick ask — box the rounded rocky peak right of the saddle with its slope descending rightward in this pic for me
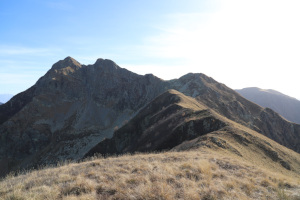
[170,74,300,152]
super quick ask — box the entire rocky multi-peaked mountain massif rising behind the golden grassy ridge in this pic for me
[0,57,300,174]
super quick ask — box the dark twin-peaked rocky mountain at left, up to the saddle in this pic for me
[0,57,165,175]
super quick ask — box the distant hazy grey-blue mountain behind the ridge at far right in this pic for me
[236,87,300,124]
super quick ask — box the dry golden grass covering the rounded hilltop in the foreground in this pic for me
[0,151,300,200]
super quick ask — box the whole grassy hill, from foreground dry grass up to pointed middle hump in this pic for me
[0,89,300,200]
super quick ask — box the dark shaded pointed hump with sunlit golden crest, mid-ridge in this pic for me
[86,90,225,156]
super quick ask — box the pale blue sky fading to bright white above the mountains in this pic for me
[0,0,300,99]
